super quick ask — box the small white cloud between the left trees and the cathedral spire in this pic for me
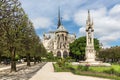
[32,17,53,29]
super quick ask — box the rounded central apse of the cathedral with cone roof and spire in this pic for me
[55,8,69,57]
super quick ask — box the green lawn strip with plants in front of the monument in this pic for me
[54,62,120,80]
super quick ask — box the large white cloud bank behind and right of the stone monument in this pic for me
[74,5,120,47]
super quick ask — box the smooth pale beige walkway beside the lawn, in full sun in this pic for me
[30,62,109,80]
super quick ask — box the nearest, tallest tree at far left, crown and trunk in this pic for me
[0,0,28,71]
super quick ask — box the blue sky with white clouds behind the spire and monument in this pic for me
[20,0,120,47]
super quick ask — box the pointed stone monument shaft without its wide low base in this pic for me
[85,10,95,62]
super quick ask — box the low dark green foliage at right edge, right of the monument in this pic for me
[97,46,120,63]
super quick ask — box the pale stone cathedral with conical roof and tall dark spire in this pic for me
[42,10,76,58]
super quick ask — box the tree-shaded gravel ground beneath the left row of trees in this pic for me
[0,63,46,80]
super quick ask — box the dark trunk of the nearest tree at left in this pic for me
[10,47,16,72]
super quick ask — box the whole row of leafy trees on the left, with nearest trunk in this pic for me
[0,0,47,71]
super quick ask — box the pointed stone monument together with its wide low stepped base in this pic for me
[79,10,111,66]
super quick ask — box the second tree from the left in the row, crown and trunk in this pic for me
[22,20,36,66]
